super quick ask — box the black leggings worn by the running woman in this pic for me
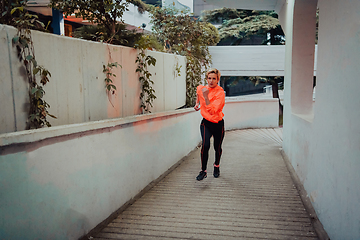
[200,118,225,171]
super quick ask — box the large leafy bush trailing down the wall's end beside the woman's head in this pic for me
[151,8,219,106]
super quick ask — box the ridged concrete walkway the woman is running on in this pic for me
[90,129,317,239]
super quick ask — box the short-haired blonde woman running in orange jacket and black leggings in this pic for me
[194,68,225,181]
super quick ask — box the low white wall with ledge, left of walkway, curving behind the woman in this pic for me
[0,99,278,239]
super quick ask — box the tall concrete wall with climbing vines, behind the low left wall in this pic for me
[0,25,186,133]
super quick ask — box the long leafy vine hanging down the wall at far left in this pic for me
[1,1,56,129]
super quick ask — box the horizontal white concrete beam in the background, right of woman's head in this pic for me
[209,45,317,76]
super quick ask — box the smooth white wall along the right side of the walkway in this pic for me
[283,0,360,240]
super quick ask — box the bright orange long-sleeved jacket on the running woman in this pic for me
[196,85,225,123]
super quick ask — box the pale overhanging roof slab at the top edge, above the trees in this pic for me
[203,0,285,12]
